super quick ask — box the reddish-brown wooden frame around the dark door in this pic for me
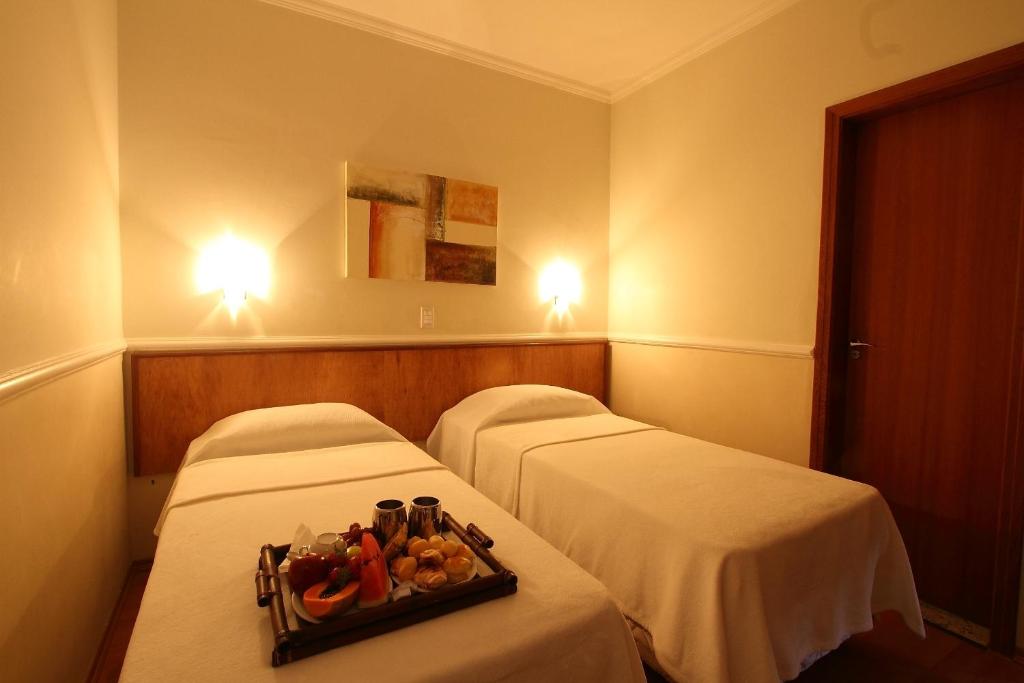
[810,43,1024,654]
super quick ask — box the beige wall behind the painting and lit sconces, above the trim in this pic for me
[120,0,609,337]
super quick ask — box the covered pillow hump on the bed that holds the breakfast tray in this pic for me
[182,403,406,467]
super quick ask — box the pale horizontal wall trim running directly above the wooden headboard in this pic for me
[128,332,607,353]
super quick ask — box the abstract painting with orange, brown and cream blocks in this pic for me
[344,163,498,285]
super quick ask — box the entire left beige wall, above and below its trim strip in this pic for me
[0,0,128,681]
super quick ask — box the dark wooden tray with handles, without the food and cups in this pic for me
[256,512,518,667]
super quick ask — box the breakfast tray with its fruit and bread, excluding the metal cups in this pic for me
[256,512,517,667]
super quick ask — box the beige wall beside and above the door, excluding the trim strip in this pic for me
[609,0,1024,463]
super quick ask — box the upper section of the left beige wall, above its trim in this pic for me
[0,0,121,374]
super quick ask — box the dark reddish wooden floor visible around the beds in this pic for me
[89,562,1024,683]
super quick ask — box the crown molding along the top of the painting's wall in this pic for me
[260,0,611,104]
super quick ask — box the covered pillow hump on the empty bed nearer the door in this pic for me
[427,384,610,483]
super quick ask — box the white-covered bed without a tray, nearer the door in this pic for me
[427,385,924,683]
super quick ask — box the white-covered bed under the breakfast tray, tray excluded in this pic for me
[121,404,644,683]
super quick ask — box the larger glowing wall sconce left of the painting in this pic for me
[196,232,270,318]
